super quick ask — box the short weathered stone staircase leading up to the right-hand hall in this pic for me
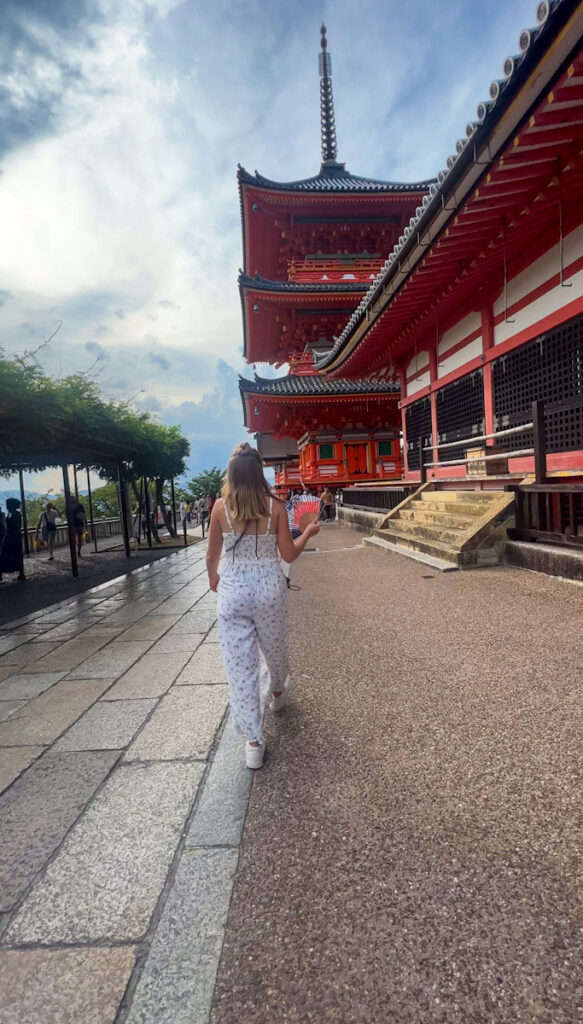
[365,482,514,570]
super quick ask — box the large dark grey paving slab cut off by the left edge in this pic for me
[0,748,119,910]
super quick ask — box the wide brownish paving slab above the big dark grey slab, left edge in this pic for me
[0,679,112,746]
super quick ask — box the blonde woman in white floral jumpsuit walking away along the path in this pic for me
[207,443,320,768]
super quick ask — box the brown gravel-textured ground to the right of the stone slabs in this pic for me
[211,527,583,1024]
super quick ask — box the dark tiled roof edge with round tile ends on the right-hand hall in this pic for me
[316,0,580,371]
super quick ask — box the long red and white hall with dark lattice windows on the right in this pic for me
[316,0,583,565]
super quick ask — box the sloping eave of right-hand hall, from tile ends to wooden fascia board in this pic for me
[316,0,583,374]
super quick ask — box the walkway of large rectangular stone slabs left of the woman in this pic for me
[0,545,251,1024]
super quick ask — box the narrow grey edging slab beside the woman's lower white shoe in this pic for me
[185,721,253,847]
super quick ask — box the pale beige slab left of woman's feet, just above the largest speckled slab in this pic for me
[125,686,228,761]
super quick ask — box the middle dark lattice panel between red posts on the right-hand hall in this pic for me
[435,370,486,462]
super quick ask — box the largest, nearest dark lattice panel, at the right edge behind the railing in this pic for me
[493,316,583,452]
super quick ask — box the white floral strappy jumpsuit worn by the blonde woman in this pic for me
[216,499,290,742]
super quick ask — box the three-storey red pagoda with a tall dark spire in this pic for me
[238,27,431,489]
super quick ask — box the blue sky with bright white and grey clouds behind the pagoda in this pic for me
[0,0,535,489]
